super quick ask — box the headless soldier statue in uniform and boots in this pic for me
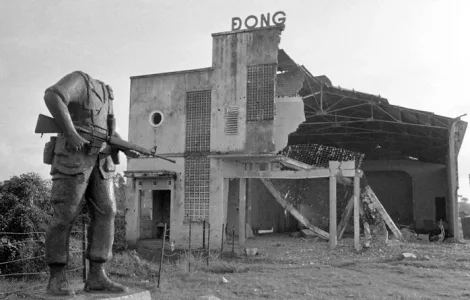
[44,71,138,295]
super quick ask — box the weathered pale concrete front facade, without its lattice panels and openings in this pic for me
[126,28,305,247]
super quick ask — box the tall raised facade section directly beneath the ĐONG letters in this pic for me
[211,29,281,153]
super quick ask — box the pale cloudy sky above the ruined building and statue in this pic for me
[0,0,470,197]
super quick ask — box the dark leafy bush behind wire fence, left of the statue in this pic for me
[0,173,52,273]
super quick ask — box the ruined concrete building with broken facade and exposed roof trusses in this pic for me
[125,22,467,247]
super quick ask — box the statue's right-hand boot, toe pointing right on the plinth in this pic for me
[84,261,129,293]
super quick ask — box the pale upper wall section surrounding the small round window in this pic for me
[128,69,212,156]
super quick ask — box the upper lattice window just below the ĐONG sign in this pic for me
[246,64,277,121]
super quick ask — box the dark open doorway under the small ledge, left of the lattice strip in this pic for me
[152,190,171,239]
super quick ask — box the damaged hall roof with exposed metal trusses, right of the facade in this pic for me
[276,50,467,164]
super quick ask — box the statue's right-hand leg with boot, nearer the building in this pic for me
[85,168,128,293]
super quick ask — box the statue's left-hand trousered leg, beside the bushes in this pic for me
[45,172,90,295]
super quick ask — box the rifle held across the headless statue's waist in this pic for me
[34,114,176,163]
